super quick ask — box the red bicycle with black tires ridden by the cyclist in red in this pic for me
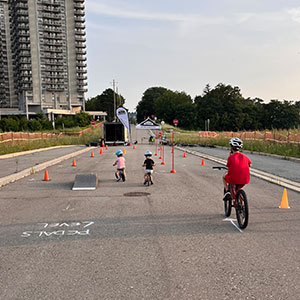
[213,167,249,229]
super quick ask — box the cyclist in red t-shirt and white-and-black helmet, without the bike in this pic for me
[223,138,251,200]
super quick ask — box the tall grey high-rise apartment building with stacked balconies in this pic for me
[0,0,87,116]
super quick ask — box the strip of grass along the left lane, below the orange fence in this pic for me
[0,127,101,155]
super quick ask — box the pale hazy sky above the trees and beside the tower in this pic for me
[85,0,300,112]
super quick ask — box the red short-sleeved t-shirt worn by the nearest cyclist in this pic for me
[226,152,251,184]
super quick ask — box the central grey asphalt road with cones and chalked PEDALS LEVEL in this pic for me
[0,131,300,300]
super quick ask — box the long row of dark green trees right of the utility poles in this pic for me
[136,83,300,131]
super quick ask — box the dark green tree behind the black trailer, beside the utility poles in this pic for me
[85,89,125,122]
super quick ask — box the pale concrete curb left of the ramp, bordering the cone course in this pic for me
[0,147,97,187]
